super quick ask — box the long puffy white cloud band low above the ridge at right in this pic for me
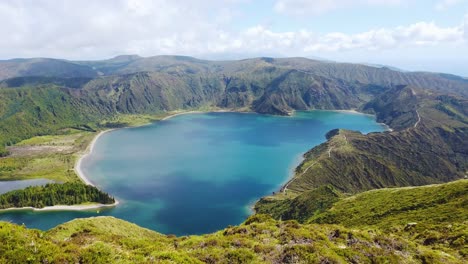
[217,22,466,55]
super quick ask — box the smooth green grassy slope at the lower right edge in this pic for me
[308,180,468,258]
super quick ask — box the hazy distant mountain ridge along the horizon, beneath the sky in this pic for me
[0,55,468,96]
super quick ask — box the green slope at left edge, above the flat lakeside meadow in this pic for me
[0,85,113,155]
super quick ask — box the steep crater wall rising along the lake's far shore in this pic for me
[0,64,384,155]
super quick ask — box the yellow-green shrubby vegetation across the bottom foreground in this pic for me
[0,215,463,263]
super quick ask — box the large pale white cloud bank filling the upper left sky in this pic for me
[0,0,241,58]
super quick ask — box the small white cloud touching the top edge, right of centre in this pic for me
[274,0,405,15]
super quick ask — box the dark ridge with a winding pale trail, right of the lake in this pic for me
[258,86,468,196]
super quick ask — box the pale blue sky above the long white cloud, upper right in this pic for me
[235,0,468,33]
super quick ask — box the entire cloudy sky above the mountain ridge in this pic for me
[0,0,468,76]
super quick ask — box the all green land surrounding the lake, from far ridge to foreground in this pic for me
[0,56,468,263]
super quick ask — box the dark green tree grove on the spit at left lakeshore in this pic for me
[0,183,115,209]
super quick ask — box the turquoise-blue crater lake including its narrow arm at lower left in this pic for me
[0,111,385,235]
